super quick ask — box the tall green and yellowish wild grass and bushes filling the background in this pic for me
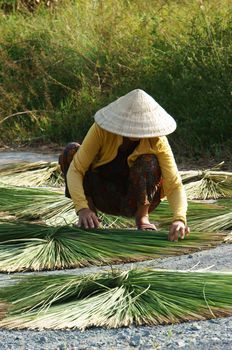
[0,0,232,157]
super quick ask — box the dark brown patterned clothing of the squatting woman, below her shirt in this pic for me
[59,138,161,217]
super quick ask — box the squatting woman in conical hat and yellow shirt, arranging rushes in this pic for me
[61,89,189,241]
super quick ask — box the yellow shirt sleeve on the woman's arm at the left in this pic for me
[67,123,102,212]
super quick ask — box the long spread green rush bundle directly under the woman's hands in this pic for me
[0,222,224,272]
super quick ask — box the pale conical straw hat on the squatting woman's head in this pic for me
[94,89,176,138]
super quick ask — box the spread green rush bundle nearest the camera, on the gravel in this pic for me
[0,269,232,330]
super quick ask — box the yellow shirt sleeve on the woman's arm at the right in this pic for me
[157,136,187,224]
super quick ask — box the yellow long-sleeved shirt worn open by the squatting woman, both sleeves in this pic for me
[67,123,187,223]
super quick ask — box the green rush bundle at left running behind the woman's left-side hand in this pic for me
[0,186,133,228]
